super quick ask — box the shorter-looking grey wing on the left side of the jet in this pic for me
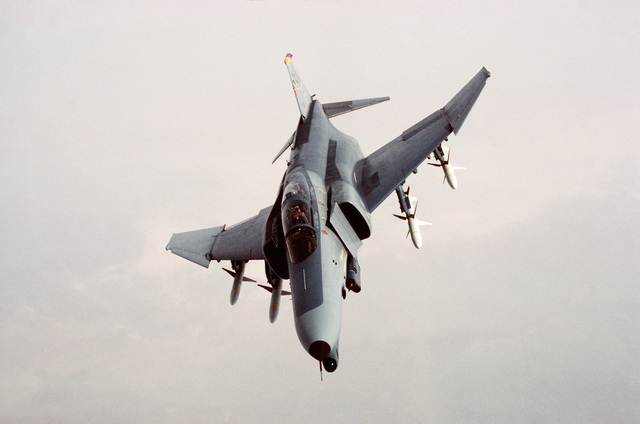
[166,206,271,268]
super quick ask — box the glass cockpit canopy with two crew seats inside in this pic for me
[282,175,318,264]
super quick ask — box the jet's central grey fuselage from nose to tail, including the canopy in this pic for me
[282,101,364,370]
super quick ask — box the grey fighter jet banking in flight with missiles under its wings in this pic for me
[167,54,490,372]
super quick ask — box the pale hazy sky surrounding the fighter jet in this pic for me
[0,1,640,424]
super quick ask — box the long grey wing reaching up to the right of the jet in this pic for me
[362,68,491,212]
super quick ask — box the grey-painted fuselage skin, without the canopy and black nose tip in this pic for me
[283,101,363,358]
